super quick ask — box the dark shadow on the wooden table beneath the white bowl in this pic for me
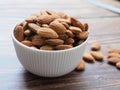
[23,70,82,90]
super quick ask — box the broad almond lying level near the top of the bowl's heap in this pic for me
[37,15,55,24]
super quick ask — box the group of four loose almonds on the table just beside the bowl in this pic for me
[76,42,104,71]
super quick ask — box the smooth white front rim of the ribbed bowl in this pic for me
[11,29,89,53]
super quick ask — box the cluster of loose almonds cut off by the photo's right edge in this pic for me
[107,49,120,69]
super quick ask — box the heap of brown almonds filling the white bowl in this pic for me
[14,10,89,50]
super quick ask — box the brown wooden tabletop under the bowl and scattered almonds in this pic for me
[0,0,120,90]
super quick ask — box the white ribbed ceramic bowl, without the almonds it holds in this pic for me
[12,32,87,77]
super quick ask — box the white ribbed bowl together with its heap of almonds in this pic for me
[12,10,89,77]
